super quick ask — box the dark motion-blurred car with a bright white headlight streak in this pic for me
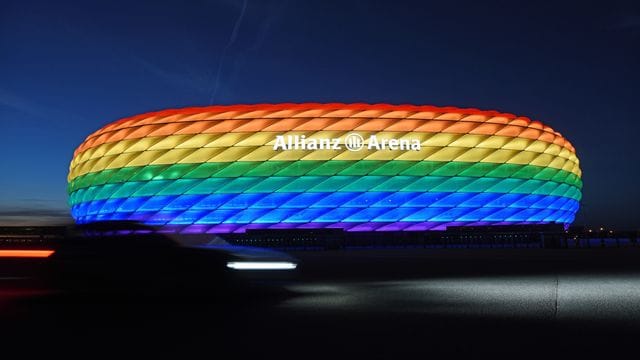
[49,221,297,295]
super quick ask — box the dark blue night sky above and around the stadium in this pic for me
[0,0,640,228]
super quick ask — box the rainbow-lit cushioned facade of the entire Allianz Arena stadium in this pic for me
[68,104,582,233]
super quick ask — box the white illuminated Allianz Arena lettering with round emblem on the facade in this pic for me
[273,133,421,151]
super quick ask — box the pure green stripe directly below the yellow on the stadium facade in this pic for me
[68,160,582,193]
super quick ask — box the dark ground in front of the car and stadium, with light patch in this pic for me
[0,248,640,359]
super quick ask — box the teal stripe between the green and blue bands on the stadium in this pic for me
[69,176,581,205]
